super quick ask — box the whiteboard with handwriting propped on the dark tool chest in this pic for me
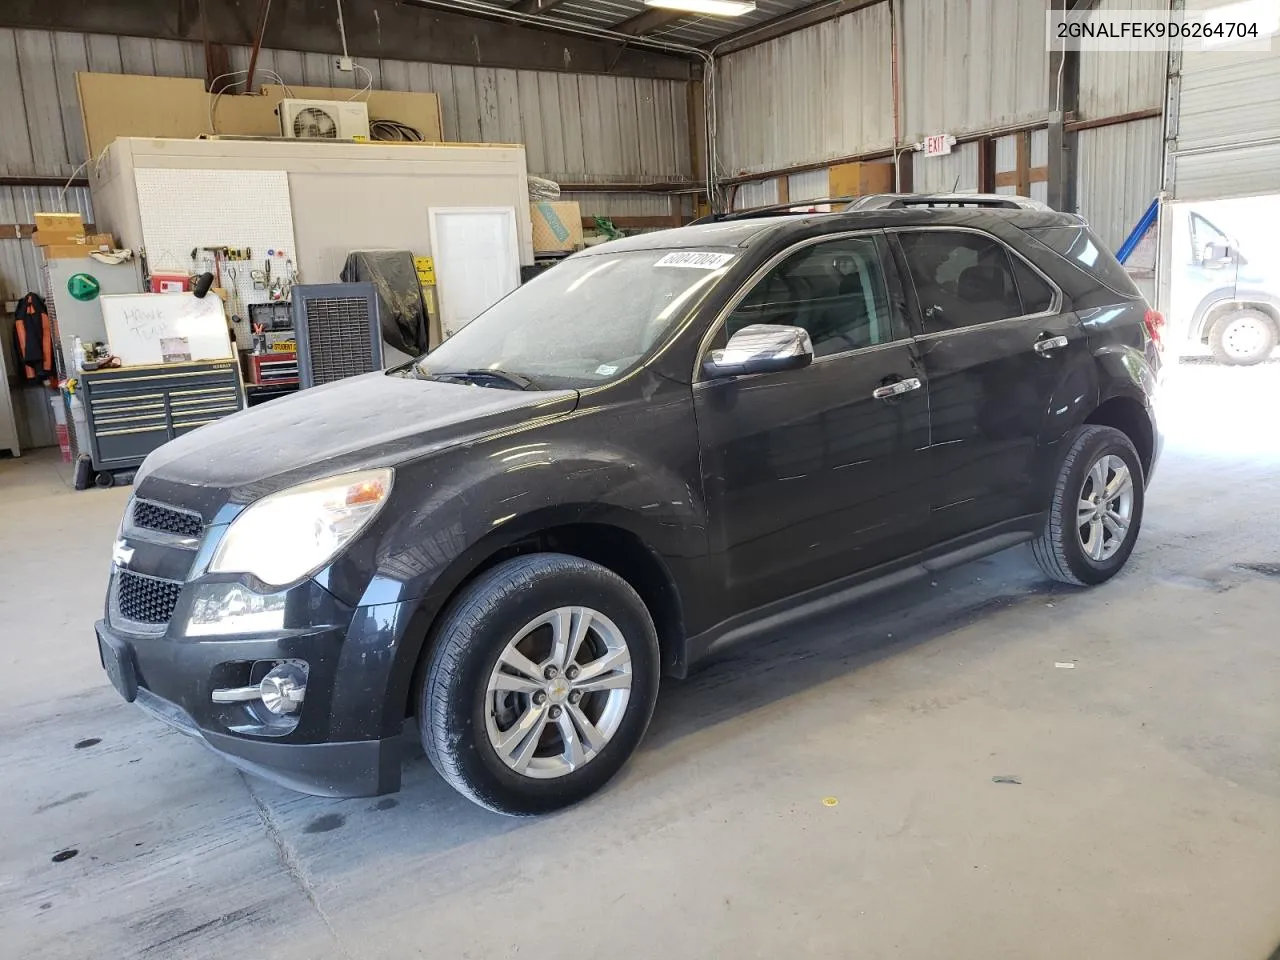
[100,293,233,366]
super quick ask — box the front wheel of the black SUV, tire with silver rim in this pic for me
[417,553,659,817]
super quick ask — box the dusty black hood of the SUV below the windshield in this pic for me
[136,372,577,500]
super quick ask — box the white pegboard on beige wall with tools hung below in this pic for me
[133,166,301,349]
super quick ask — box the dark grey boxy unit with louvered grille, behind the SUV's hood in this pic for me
[289,283,383,389]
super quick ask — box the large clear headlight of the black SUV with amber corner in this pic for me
[209,468,394,586]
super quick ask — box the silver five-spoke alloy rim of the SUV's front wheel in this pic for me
[485,607,632,780]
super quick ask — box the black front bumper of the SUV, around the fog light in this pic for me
[95,591,412,797]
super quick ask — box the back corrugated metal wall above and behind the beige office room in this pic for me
[0,29,692,297]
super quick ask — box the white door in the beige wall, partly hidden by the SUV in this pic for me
[428,206,520,337]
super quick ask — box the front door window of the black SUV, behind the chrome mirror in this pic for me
[724,237,897,357]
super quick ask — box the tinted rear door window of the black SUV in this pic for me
[899,230,1030,333]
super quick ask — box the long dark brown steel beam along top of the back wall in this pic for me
[0,0,691,79]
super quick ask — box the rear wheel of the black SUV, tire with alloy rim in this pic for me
[1032,425,1144,586]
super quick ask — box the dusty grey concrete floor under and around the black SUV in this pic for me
[0,365,1280,960]
